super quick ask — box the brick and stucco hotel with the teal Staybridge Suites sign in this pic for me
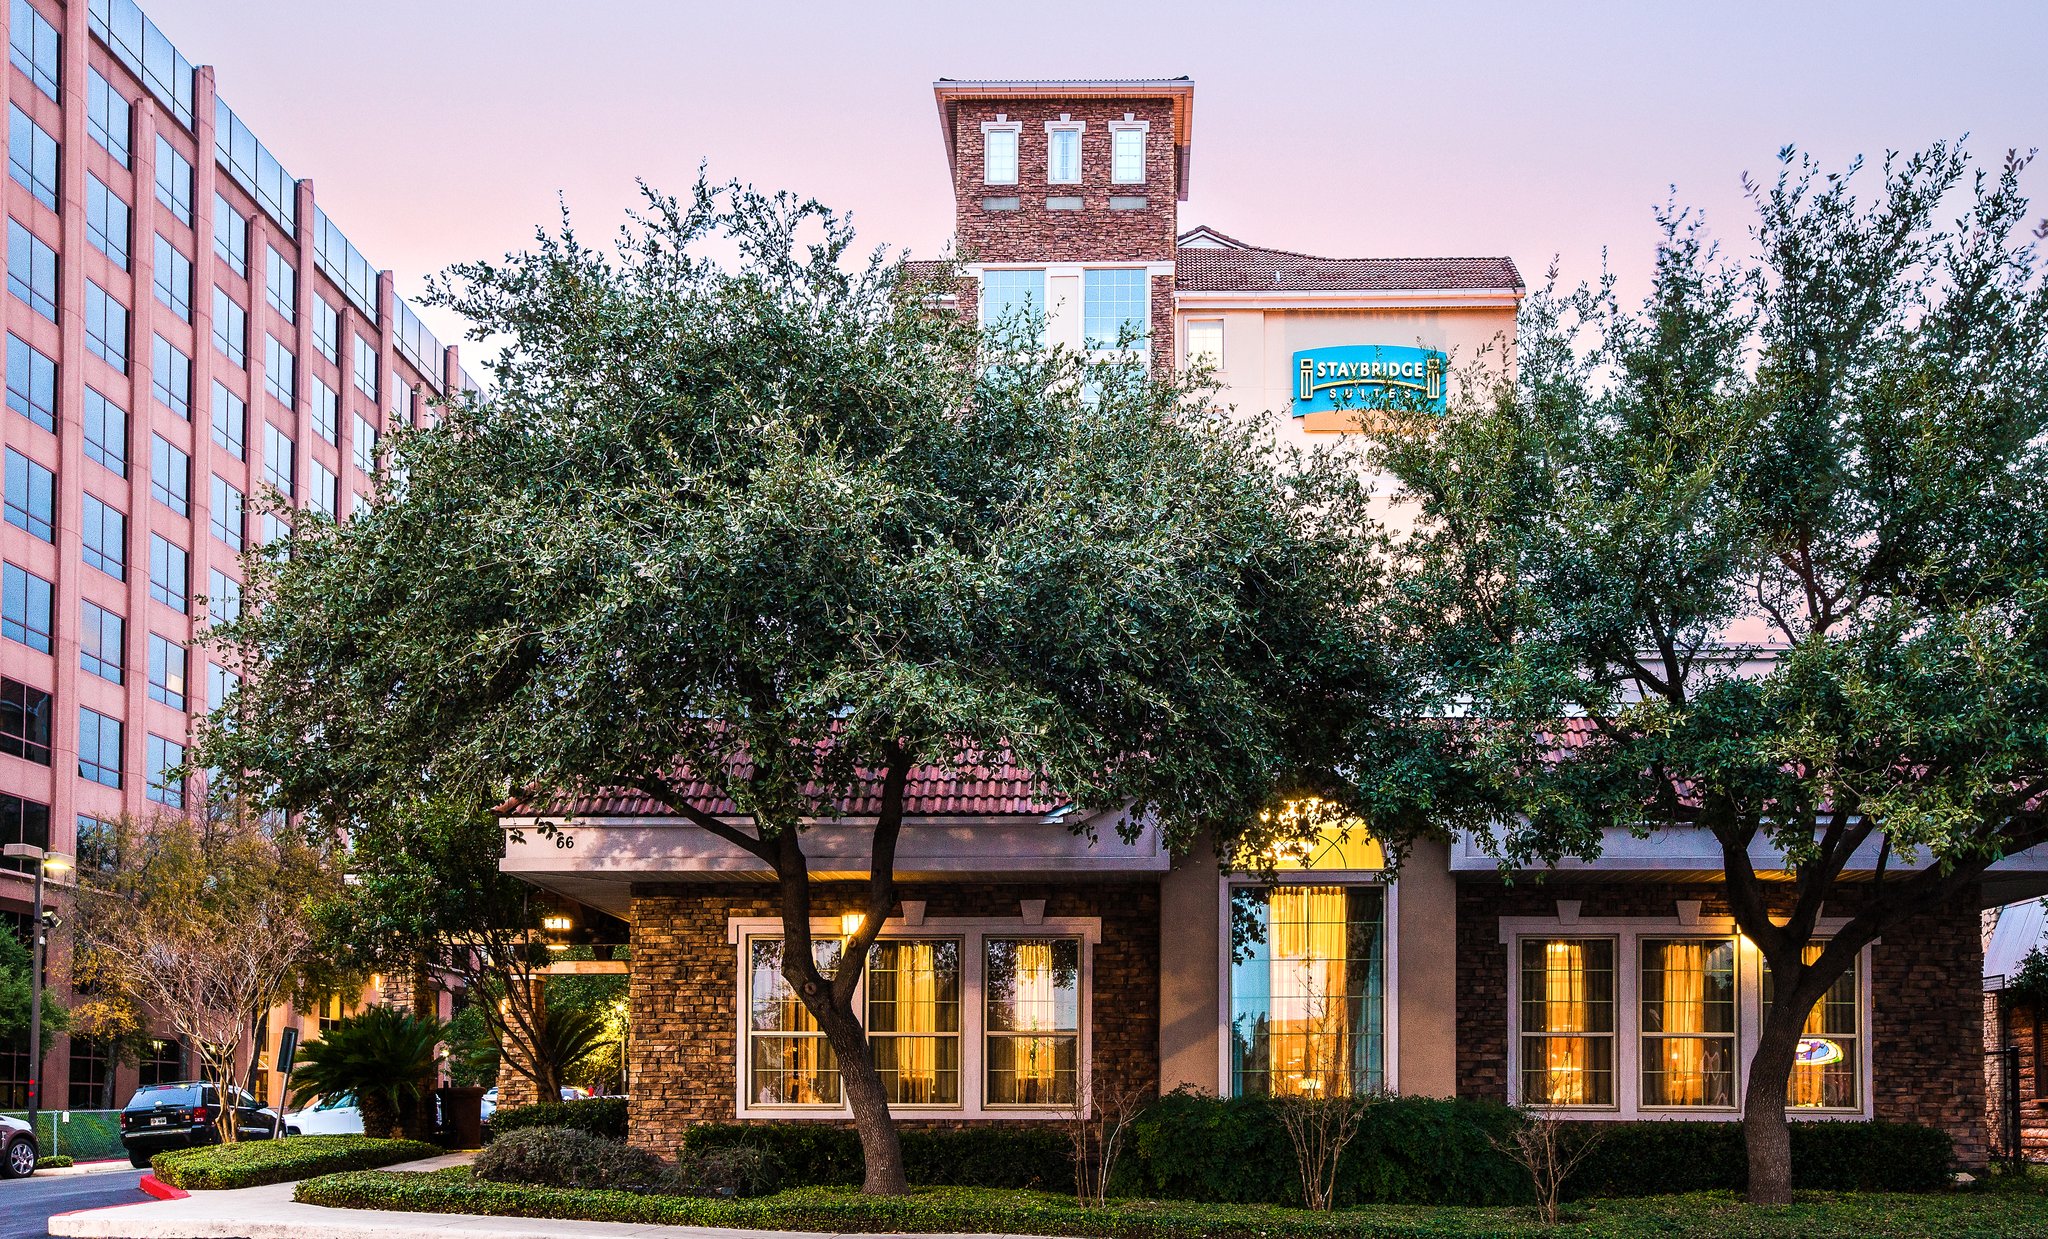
[502,78,2048,1163]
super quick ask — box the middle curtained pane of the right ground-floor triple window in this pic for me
[1638,938,1737,1108]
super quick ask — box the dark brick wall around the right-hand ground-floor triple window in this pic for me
[1458,879,1987,1165]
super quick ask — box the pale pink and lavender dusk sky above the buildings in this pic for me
[143,0,2048,360]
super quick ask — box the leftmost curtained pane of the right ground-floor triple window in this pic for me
[1520,938,1614,1106]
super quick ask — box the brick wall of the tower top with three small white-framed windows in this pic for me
[952,98,1180,262]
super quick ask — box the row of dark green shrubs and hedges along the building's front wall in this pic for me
[682,1092,1952,1208]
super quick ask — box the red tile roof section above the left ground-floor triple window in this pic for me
[509,754,1065,817]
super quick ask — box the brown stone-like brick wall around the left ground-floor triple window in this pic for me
[629,883,1159,1157]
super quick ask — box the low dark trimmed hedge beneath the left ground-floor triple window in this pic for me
[682,1122,1073,1192]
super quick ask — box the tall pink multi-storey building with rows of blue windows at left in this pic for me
[0,0,469,1110]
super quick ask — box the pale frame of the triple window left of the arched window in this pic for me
[725,915,1102,1122]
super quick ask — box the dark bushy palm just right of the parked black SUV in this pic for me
[291,1008,446,1137]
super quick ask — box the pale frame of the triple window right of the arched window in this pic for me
[1499,899,1878,1122]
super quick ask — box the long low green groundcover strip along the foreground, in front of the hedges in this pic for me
[293,1167,2048,1239]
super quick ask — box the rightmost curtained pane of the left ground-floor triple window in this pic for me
[983,938,1081,1106]
